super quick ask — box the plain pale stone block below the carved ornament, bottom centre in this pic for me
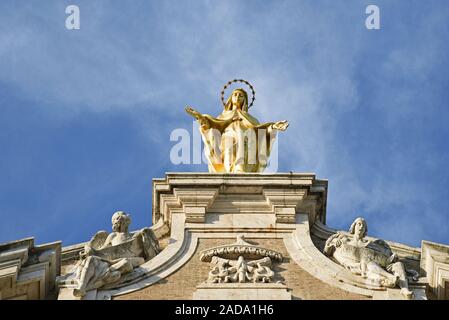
[193,283,292,300]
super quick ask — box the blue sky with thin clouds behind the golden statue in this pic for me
[0,0,449,246]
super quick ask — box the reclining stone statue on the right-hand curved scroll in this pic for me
[324,217,416,299]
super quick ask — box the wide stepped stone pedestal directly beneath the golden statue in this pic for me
[152,173,327,230]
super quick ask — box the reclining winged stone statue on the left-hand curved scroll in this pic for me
[58,211,160,297]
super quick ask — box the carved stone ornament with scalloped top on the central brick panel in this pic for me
[200,235,282,283]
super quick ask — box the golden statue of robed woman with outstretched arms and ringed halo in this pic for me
[186,80,288,173]
